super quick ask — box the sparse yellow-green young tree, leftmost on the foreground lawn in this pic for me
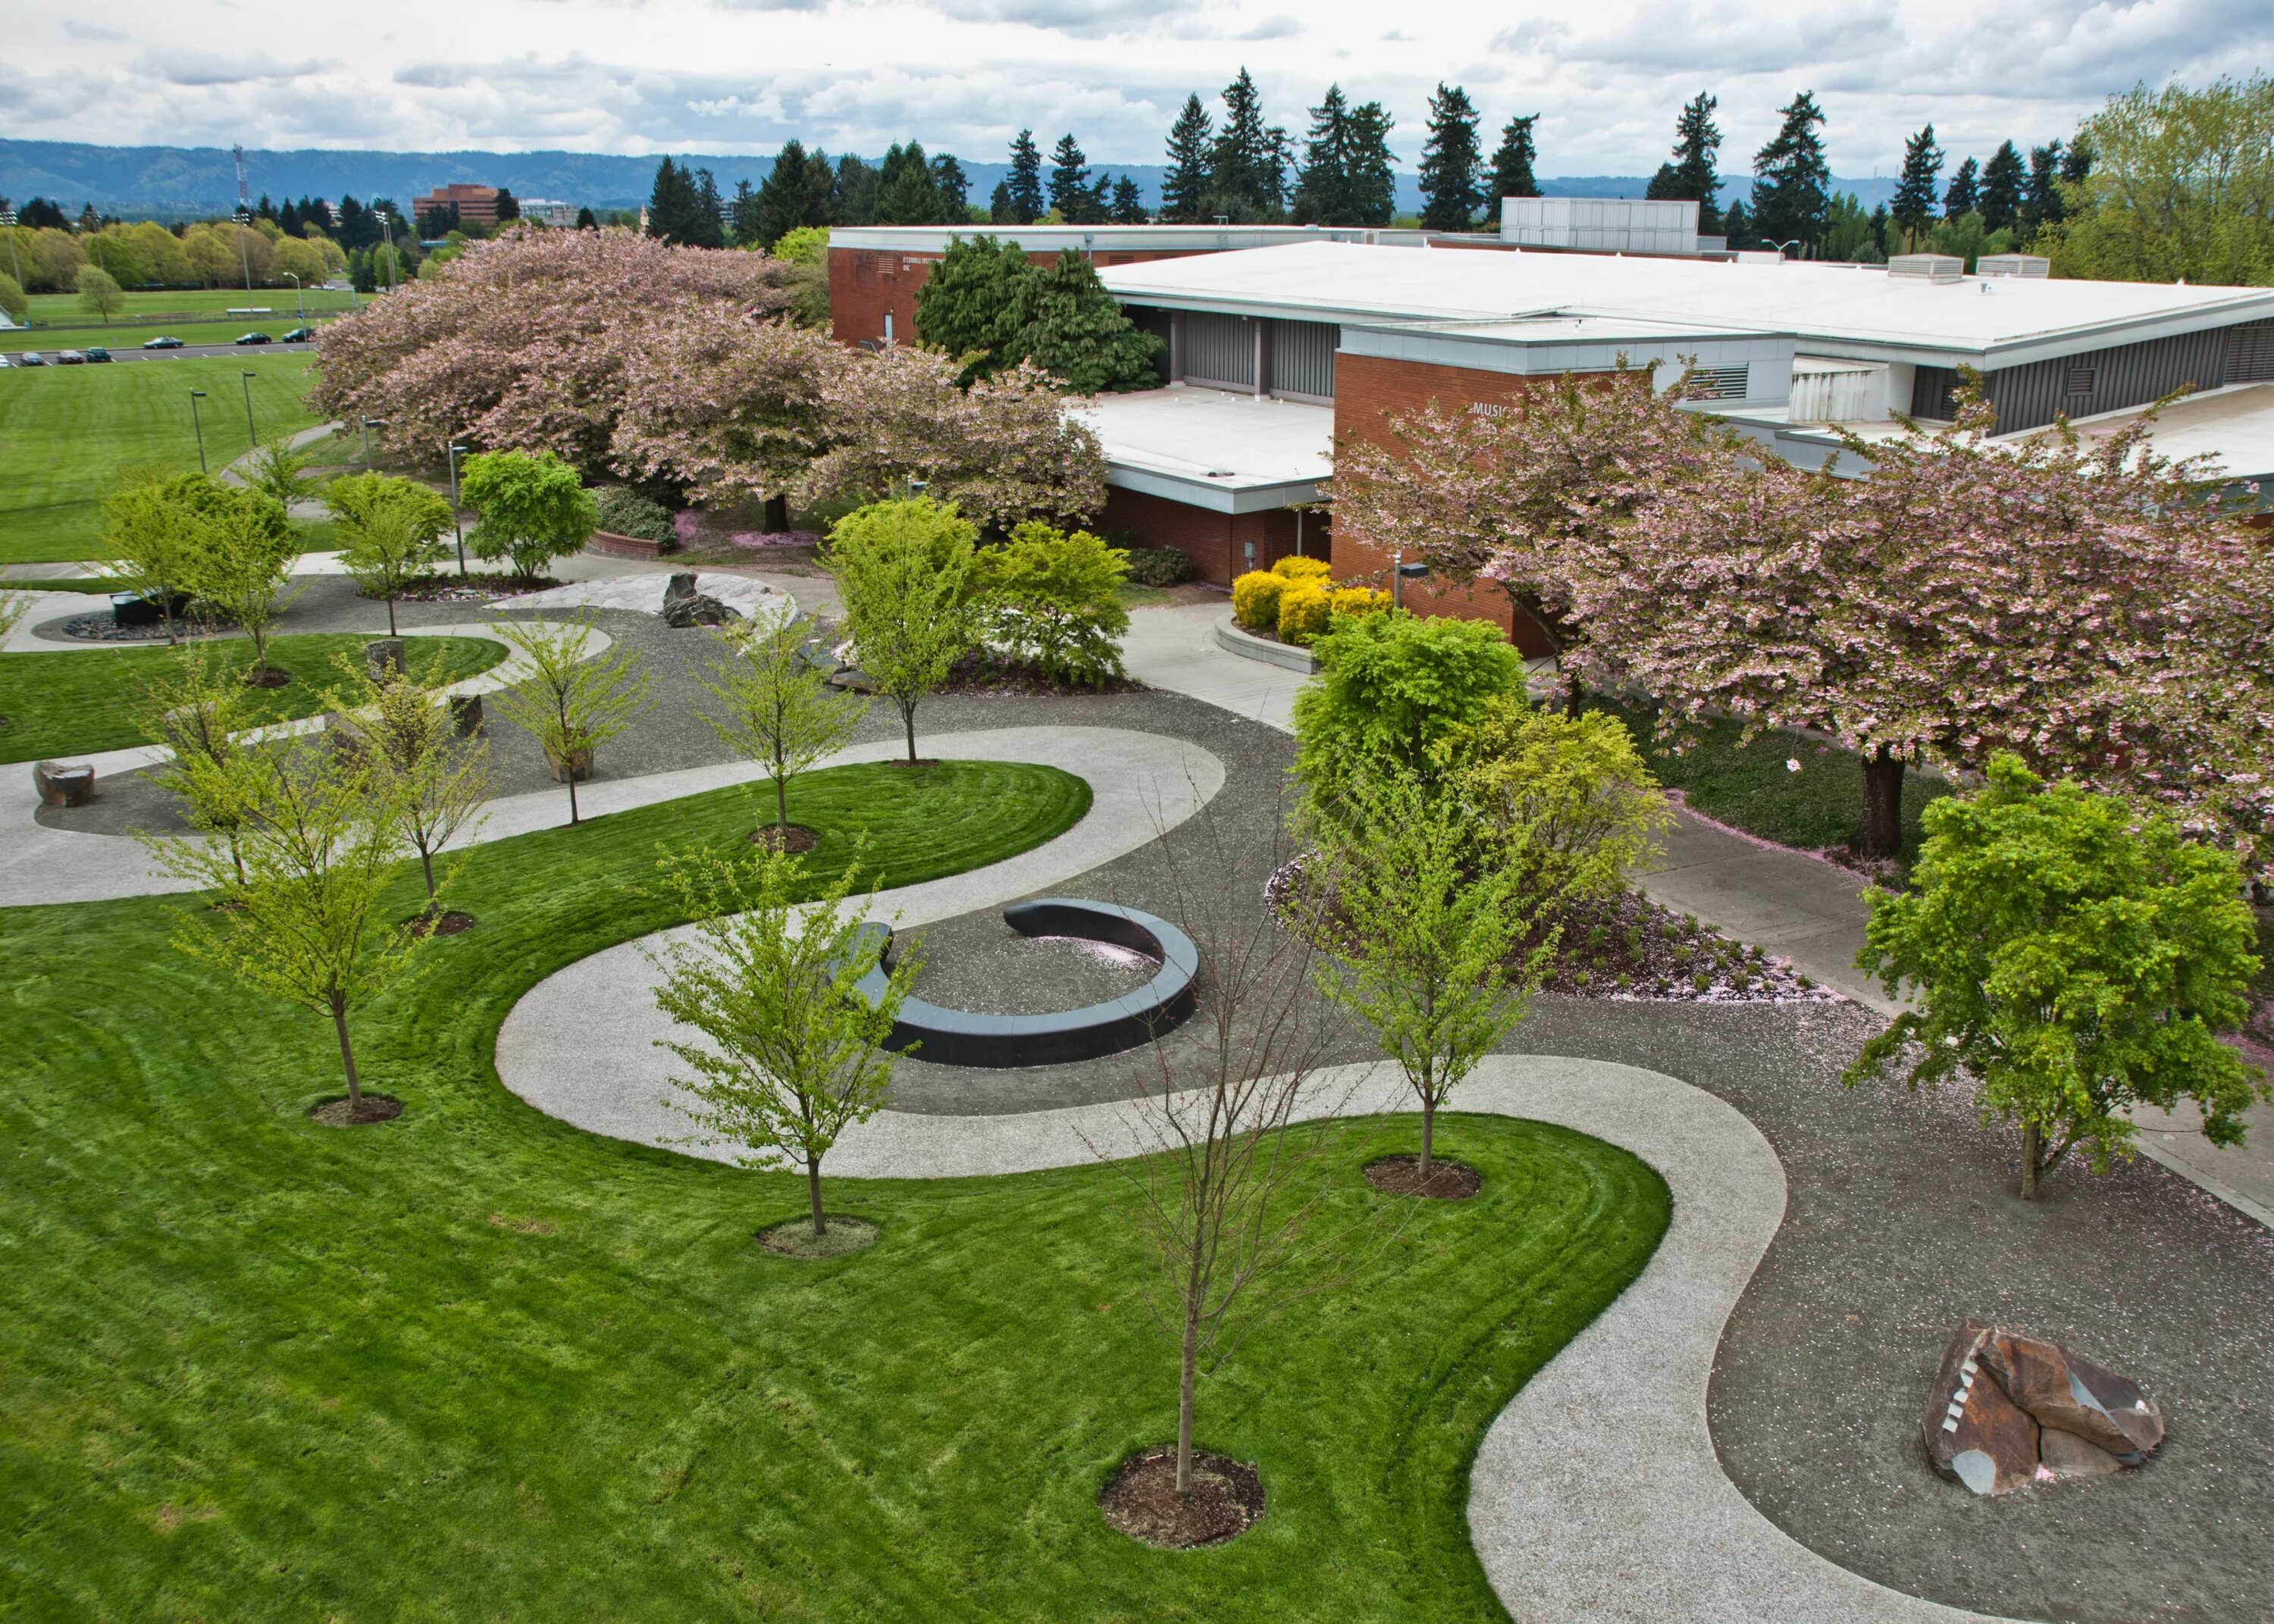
[148,734,423,1122]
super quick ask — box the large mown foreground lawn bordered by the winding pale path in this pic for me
[0,762,1669,1624]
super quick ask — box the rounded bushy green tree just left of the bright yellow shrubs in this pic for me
[978,518,1130,687]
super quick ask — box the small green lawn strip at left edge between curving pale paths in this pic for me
[0,632,505,762]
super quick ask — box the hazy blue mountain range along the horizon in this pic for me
[0,141,1894,218]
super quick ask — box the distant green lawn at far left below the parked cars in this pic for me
[0,350,316,564]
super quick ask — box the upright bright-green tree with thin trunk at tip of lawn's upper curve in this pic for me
[828,496,980,766]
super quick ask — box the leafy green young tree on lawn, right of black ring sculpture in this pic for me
[1314,768,1555,1183]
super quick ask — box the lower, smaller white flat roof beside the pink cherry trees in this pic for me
[1067,384,1335,514]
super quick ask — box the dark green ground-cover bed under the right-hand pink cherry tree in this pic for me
[1587,698,1951,862]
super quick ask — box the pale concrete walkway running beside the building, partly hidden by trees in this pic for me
[1123,602,2274,1228]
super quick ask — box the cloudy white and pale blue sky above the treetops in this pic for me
[0,0,2274,175]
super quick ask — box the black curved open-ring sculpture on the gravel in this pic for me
[860,896,1201,1069]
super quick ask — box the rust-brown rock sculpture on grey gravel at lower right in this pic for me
[1922,1319,2163,1494]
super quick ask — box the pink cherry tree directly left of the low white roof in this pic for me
[805,348,1105,530]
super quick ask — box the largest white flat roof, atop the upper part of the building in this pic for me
[1098,241,2274,366]
